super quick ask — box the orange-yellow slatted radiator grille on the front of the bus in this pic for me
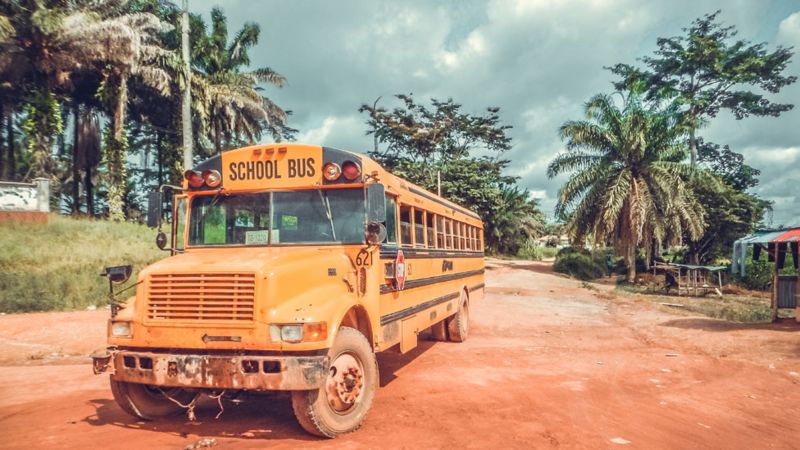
[147,273,256,322]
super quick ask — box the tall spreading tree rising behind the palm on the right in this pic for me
[610,11,797,165]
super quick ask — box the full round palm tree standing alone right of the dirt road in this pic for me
[548,92,705,282]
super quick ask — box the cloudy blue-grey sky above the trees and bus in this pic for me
[190,0,800,225]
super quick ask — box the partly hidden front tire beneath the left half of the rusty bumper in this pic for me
[111,379,195,420]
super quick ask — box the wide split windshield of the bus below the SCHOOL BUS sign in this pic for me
[189,189,365,245]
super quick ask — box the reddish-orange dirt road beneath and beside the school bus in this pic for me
[0,262,800,449]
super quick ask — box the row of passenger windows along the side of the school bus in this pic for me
[386,195,483,251]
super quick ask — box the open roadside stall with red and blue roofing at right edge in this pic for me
[731,227,800,322]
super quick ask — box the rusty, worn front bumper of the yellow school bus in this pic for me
[92,348,329,391]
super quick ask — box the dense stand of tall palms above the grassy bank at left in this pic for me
[0,0,296,219]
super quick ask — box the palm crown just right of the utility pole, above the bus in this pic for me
[192,8,287,153]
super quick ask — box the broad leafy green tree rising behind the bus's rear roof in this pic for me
[359,95,544,255]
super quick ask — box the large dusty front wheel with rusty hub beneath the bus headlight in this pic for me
[292,327,378,438]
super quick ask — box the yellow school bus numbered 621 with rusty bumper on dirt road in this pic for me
[94,144,484,437]
